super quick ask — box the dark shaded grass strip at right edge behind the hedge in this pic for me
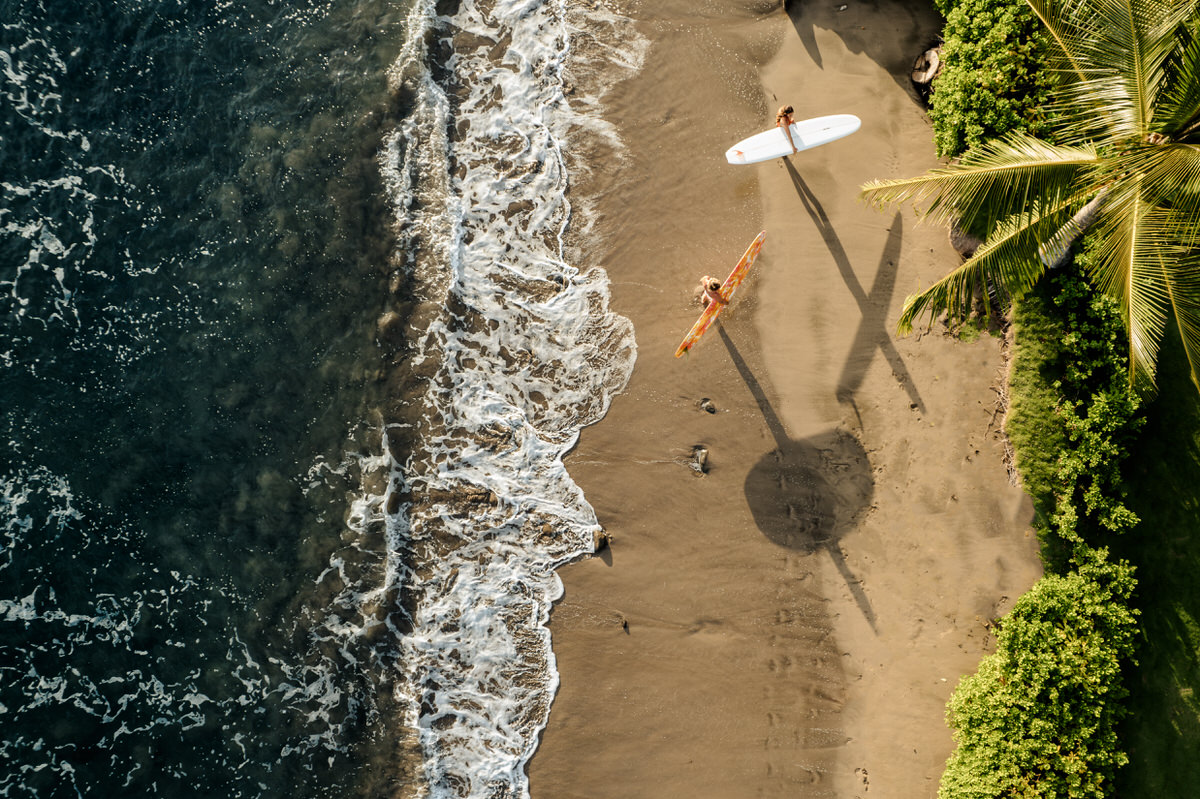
[1112,331,1200,799]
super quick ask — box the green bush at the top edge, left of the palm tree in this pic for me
[929,0,1050,156]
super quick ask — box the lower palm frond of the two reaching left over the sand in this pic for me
[896,203,1070,335]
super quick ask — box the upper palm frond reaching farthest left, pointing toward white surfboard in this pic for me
[862,133,1097,227]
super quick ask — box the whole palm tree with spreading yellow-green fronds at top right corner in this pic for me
[863,0,1200,390]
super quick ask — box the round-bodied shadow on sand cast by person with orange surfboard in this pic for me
[716,322,875,630]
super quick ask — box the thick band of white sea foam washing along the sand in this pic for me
[376,0,644,797]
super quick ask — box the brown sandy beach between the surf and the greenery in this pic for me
[529,0,1040,799]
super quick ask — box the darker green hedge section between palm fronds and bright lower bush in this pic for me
[1008,238,1144,570]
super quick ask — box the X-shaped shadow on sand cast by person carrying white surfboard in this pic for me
[784,158,925,417]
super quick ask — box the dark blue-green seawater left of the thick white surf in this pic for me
[0,0,418,799]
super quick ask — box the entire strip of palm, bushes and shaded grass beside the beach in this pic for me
[864,0,1200,799]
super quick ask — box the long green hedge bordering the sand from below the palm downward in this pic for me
[964,242,1144,799]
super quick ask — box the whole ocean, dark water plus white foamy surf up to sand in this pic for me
[0,0,644,798]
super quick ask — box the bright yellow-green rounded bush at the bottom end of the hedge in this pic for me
[938,551,1136,799]
